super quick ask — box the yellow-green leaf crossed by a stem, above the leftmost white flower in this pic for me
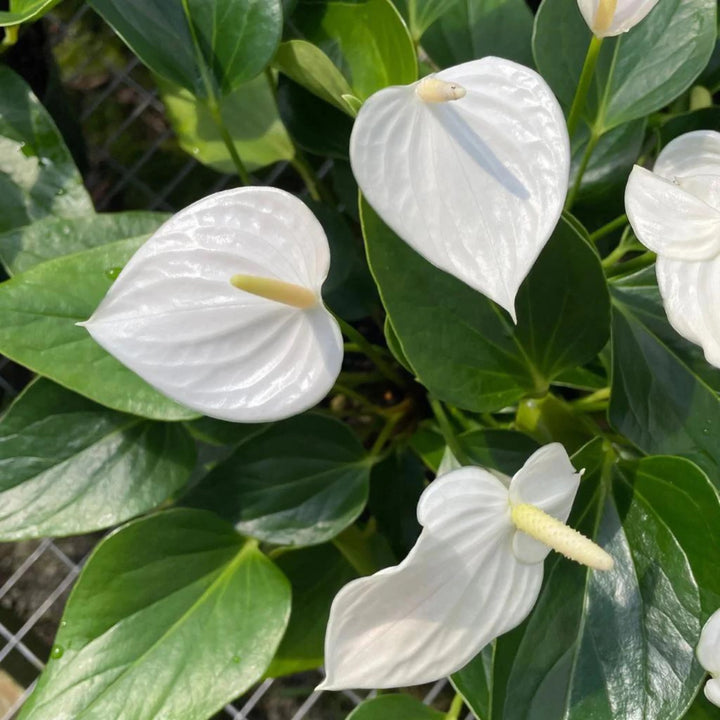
[158,74,295,173]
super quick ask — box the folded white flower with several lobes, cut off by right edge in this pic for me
[625,130,720,367]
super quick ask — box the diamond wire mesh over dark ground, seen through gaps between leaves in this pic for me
[0,1,473,720]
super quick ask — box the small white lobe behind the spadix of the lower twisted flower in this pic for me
[510,443,582,563]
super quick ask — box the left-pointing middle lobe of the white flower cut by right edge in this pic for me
[625,165,720,260]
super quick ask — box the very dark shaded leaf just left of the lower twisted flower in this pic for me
[368,450,425,559]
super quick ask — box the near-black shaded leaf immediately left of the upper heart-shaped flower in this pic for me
[277,75,352,160]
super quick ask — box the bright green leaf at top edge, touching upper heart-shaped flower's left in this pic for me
[292,0,417,101]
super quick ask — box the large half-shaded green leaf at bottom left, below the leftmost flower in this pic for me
[20,510,290,720]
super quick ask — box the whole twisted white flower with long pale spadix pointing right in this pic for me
[319,443,613,690]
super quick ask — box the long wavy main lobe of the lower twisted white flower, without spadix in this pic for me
[320,468,543,690]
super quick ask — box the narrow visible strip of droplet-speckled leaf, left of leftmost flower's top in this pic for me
[0,212,168,275]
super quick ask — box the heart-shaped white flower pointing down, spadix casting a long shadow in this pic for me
[350,57,570,319]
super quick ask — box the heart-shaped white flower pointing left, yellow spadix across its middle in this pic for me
[80,187,343,422]
